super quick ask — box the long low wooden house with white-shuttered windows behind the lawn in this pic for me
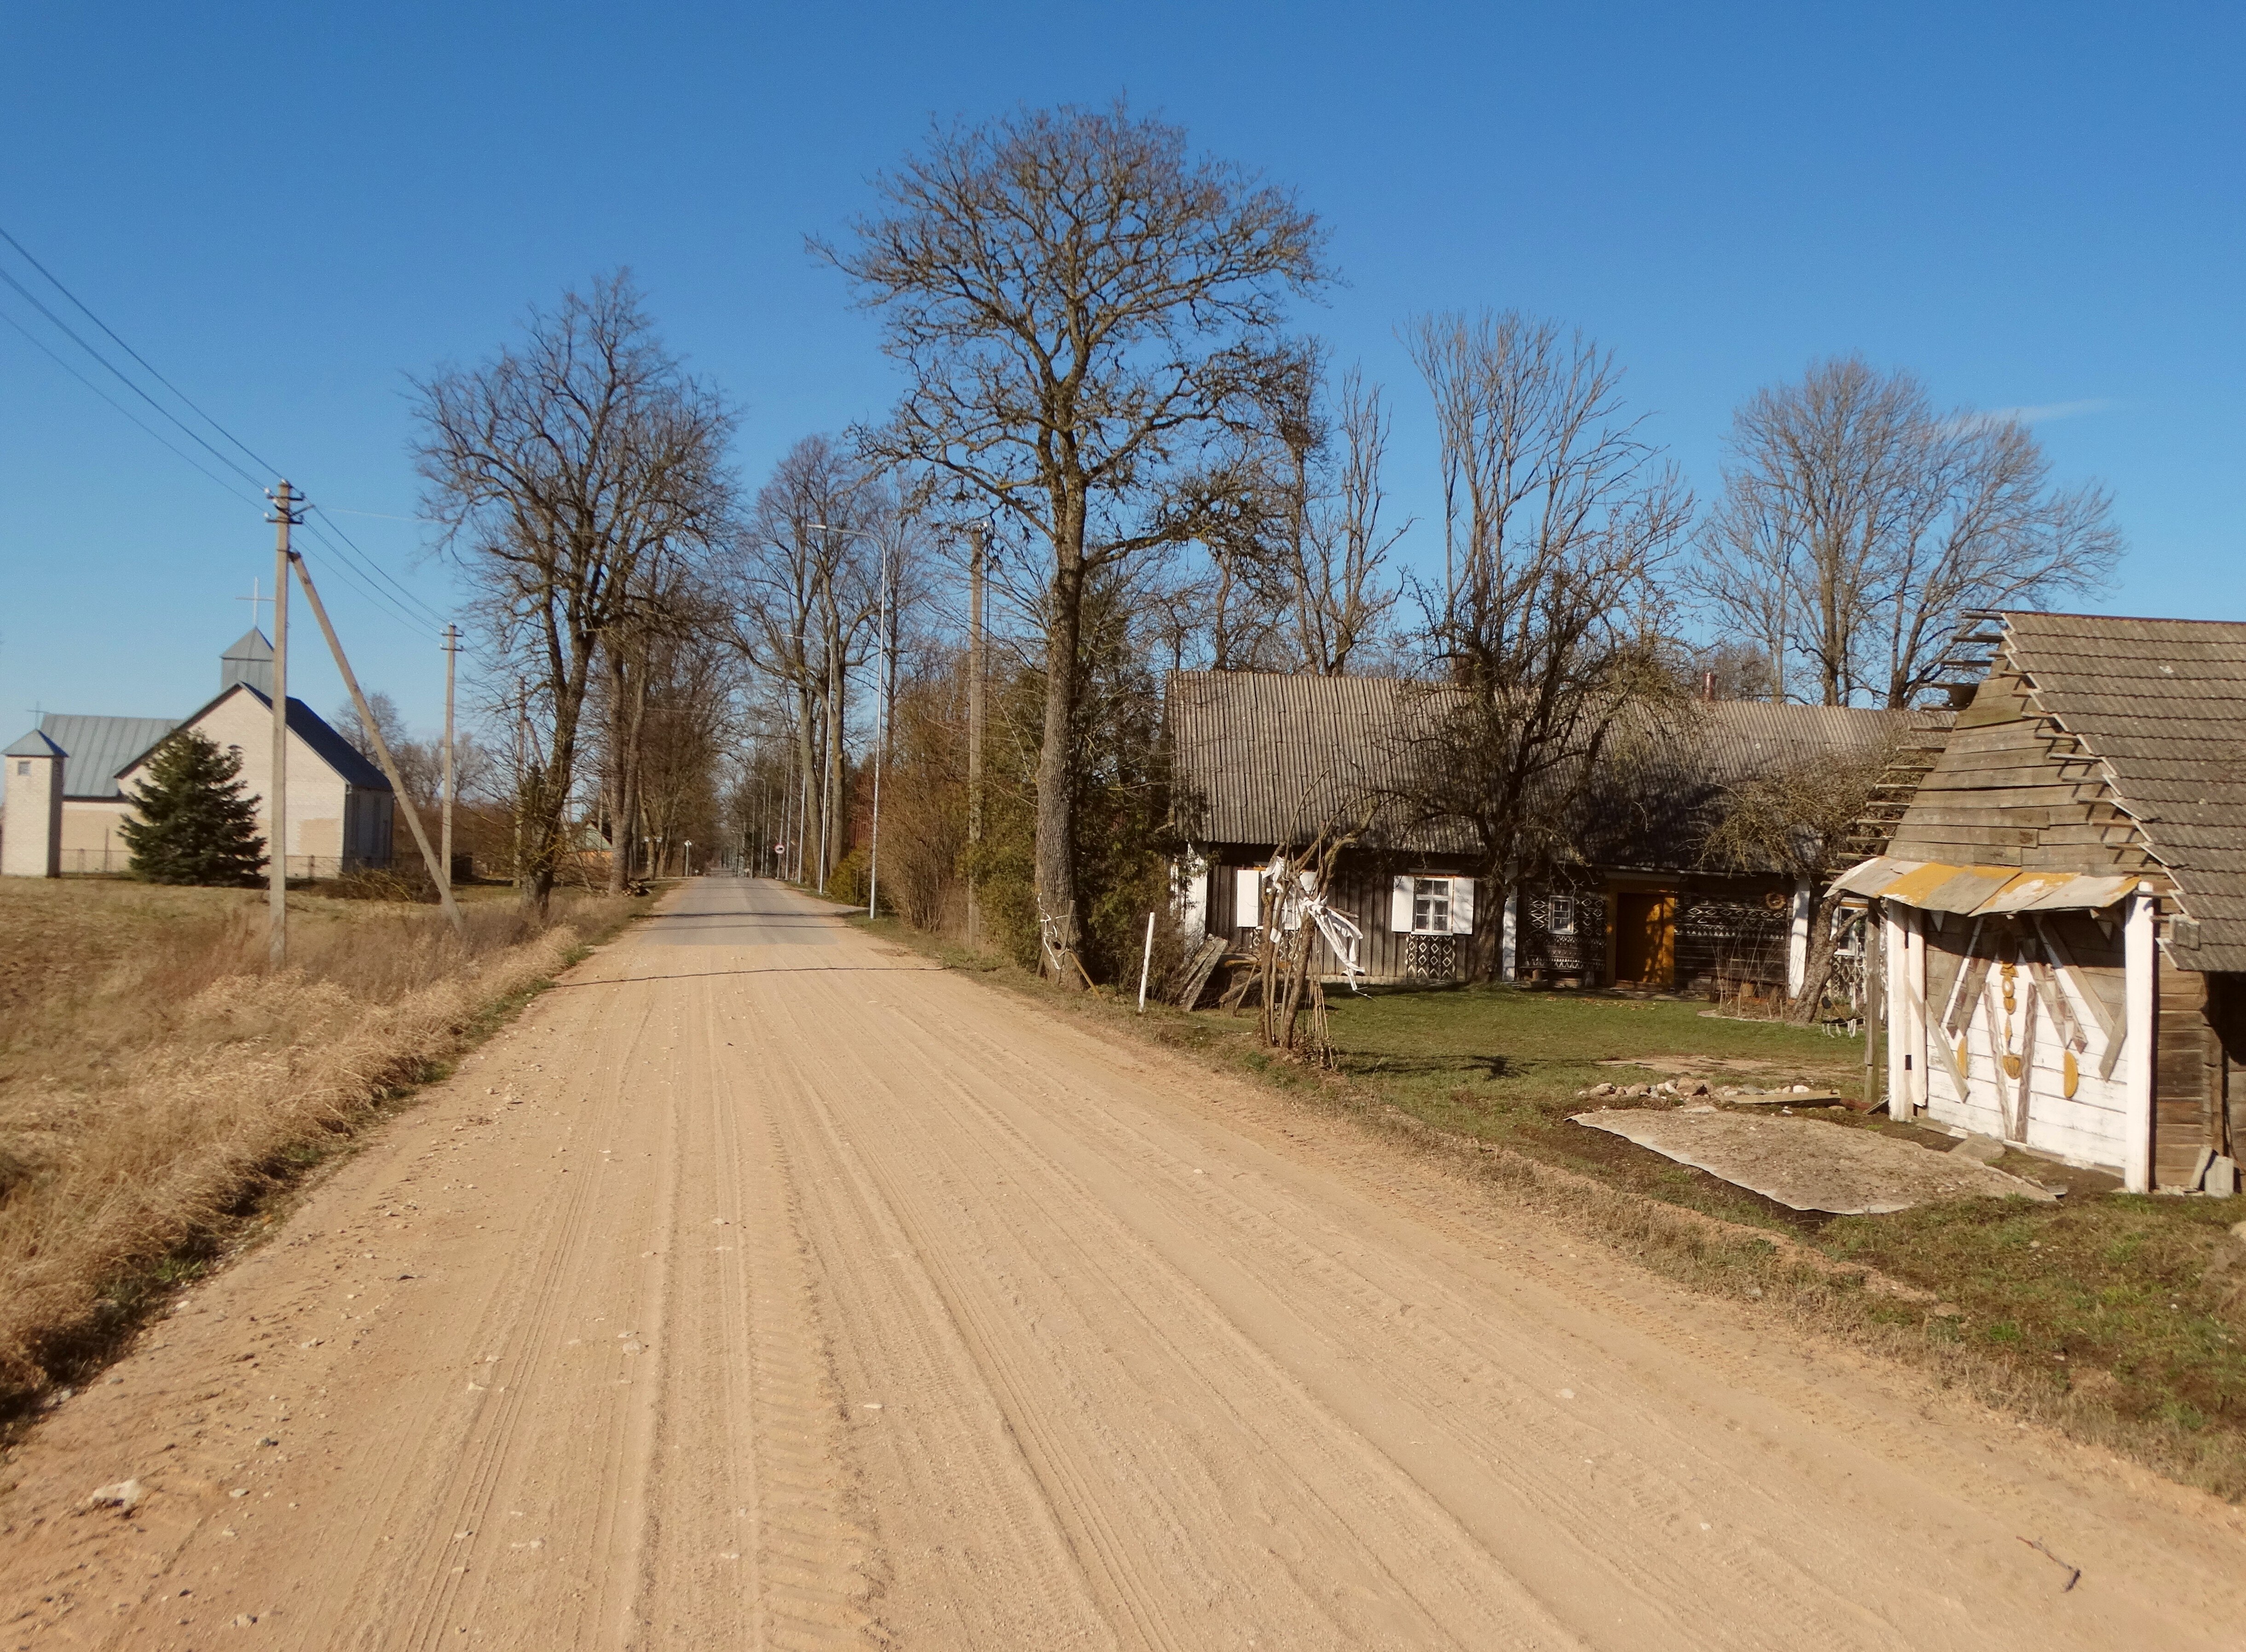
[1166,671,1947,992]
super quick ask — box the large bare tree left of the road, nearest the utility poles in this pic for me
[413,271,732,911]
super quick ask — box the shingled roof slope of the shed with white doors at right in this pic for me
[2004,613,2246,970]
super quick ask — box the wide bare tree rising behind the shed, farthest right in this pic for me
[1691,355,2123,707]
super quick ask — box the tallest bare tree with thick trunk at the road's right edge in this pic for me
[813,105,1323,979]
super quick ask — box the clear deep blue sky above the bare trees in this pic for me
[0,2,2246,734]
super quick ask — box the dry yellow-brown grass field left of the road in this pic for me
[0,880,629,1414]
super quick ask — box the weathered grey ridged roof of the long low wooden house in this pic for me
[1168,671,1950,869]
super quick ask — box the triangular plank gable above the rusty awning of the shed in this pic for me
[1887,669,2147,873]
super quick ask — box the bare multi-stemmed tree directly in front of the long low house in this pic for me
[1395,312,1691,974]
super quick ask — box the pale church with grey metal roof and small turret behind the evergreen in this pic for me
[0,631,393,878]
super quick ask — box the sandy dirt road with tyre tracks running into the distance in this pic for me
[0,880,2246,1652]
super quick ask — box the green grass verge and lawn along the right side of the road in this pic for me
[858,918,2246,1502]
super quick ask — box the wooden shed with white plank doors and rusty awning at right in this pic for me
[1842,613,2246,1192]
